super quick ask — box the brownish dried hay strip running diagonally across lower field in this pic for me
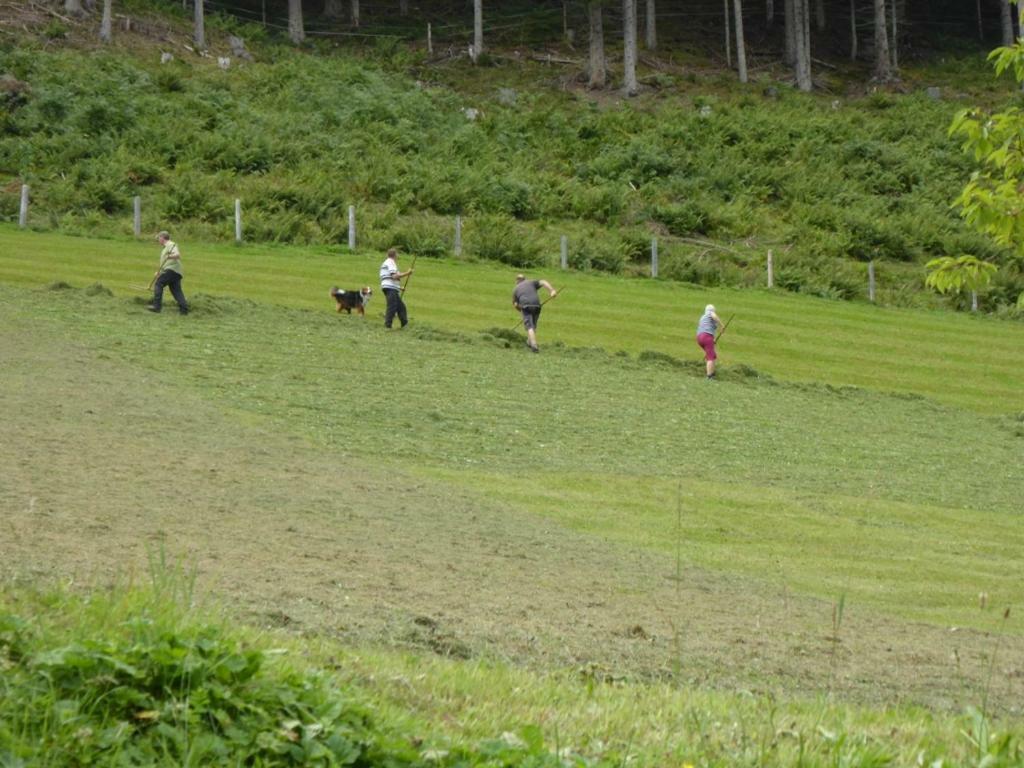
[0,306,1024,710]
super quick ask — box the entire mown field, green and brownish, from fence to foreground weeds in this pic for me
[0,228,1024,765]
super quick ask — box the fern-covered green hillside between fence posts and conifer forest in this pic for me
[0,3,1024,308]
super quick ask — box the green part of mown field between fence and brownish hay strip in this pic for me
[0,222,1024,628]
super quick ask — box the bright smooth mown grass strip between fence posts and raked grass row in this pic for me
[0,226,1024,414]
